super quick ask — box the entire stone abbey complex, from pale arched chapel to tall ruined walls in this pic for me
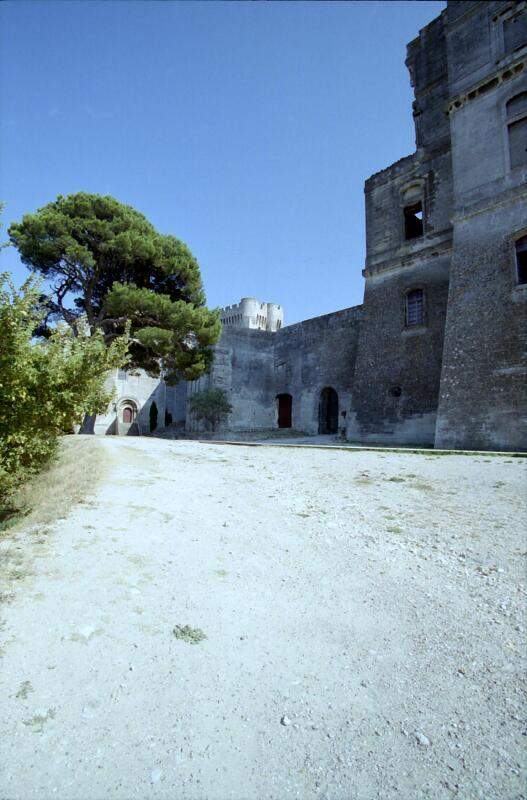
[98,0,527,450]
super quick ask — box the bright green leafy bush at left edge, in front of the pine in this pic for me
[0,274,128,507]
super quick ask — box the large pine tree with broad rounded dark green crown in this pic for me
[8,192,221,383]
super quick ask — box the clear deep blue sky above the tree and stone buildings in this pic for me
[0,0,445,323]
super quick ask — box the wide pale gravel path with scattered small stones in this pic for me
[0,437,527,800]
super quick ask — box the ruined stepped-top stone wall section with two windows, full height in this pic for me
[348,6,452,445]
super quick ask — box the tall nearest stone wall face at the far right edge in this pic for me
[436,2,527,449]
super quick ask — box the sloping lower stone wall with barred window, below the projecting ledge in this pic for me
[348,253,450,445]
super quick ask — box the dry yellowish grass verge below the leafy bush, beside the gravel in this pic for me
[0,435,107,533]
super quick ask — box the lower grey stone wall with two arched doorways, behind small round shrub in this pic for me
[187,306,361,433]
